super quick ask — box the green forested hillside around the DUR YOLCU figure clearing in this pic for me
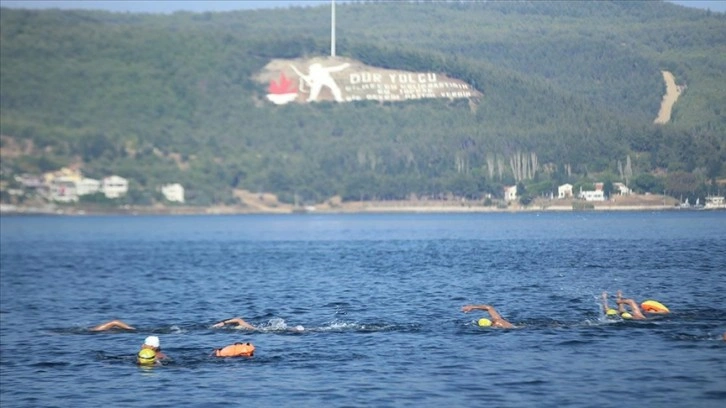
[0,1,726,205]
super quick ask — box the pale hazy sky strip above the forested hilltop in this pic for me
[0,0,726,13]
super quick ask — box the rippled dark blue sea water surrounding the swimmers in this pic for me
[0,211,726,408]
